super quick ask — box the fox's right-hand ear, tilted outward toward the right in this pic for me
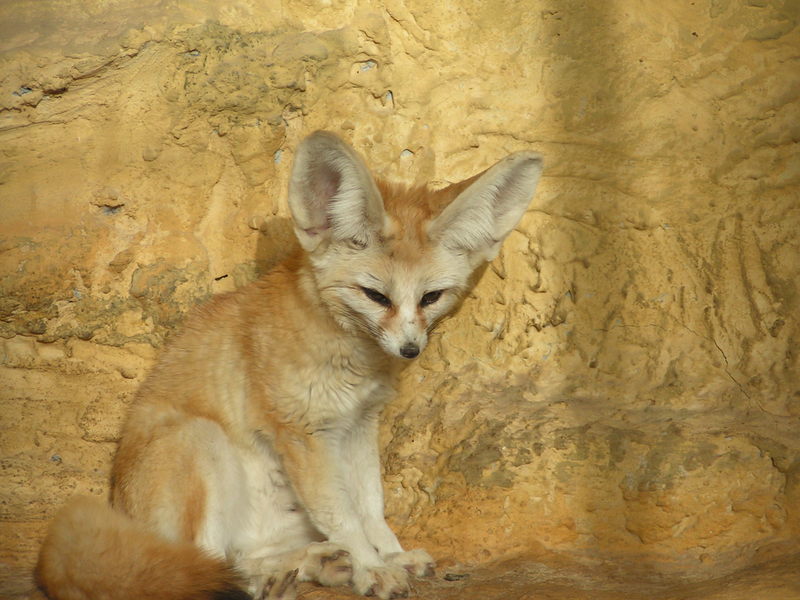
[428,152,544,266]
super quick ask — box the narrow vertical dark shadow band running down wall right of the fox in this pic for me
[543,3,664,576]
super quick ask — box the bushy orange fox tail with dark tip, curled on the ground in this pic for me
[36,498,250,600]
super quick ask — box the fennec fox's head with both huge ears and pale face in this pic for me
[289,131,542,359]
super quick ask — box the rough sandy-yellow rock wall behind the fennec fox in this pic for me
[0,0,800,593]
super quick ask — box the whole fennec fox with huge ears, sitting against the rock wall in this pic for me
[32,132,542,600]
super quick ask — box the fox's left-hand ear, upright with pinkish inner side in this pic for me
[289,131,384,252]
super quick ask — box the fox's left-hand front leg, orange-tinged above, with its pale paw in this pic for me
[275,428,409,600]
